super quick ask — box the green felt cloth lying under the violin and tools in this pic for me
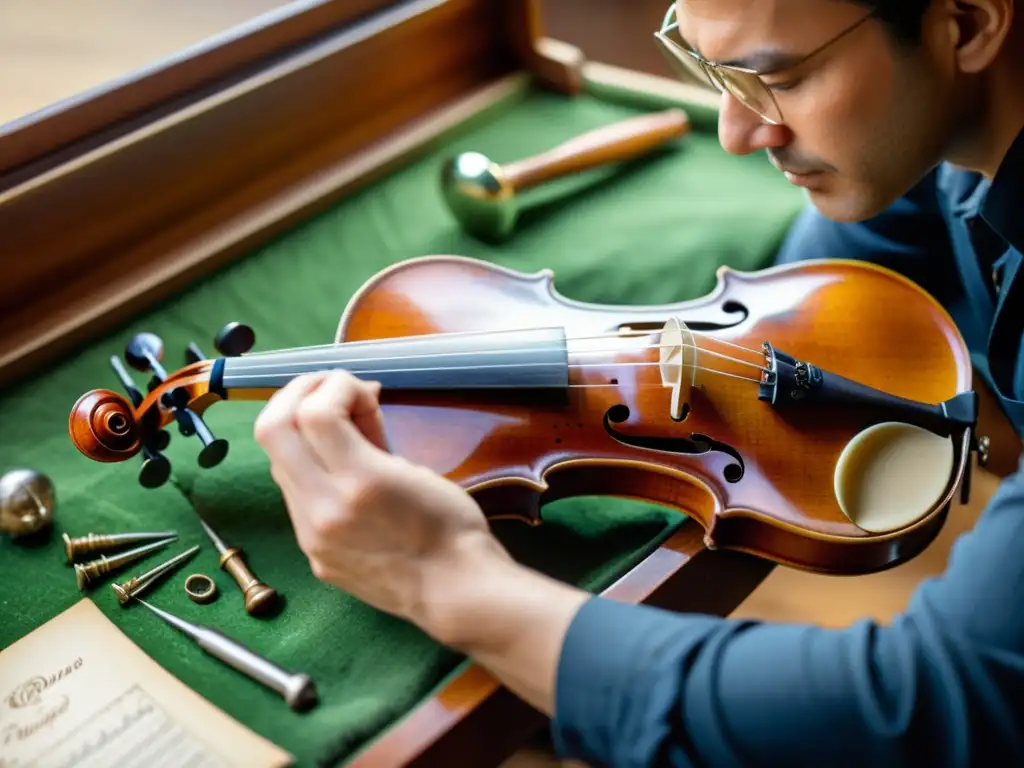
[0,78,803,765]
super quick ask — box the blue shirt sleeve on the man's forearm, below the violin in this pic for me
[552,468,1024,768]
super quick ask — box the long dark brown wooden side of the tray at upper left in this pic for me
[0,0,537,384]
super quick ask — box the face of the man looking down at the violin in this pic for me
[676,0,958,221]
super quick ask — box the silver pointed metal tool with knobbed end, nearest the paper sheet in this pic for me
[134,597,318,712]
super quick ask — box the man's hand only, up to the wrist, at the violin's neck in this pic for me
[254,372,505,630]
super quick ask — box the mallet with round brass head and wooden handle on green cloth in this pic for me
[441,108,691,241]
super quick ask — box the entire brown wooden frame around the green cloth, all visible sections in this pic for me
[0,0,753,768]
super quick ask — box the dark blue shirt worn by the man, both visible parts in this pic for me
[552,128,1024,768]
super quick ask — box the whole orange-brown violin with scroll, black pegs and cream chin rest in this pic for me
[69,256,980,574]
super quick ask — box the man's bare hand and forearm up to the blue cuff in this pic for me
[255,372,589,715]
